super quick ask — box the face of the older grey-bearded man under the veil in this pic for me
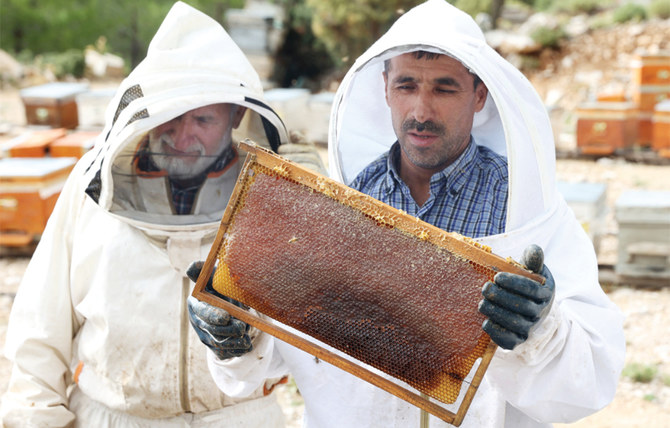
[149,104,245,178]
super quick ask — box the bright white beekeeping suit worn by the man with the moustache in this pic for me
[210,0,625,428]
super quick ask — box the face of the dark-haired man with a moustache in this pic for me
[384,53,488,173]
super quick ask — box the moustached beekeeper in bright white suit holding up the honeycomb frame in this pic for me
[193,0,625,428]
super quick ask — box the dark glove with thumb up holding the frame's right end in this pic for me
[479,245,555,349]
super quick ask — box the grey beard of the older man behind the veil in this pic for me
[149,133,224,179]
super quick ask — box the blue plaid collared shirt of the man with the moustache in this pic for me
[350,140,508,238]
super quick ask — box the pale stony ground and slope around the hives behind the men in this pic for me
[0,14,670,428]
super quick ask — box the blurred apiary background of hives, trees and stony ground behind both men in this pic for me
[0,0,670,427]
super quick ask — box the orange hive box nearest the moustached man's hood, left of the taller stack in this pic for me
[577,102,638,155]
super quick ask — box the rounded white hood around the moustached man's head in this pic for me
[329,0,555,239]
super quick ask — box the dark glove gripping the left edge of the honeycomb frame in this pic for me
[186,262,252,360]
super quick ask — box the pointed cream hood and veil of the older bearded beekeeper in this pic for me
[80,2,288,229]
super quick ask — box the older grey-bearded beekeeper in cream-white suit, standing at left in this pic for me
[2,3,320,428]
